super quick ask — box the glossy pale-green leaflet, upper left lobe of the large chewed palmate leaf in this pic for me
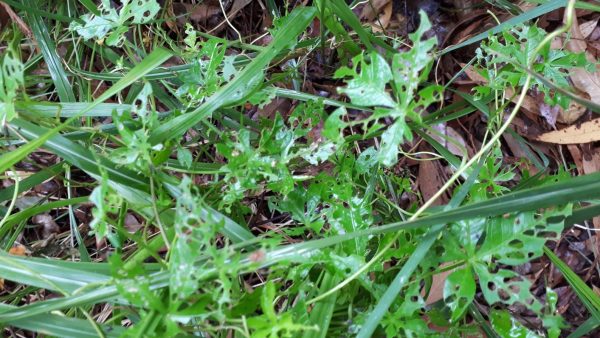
[336,52,396,107]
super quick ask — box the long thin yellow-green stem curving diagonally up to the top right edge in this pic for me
[306,0,575,305]
